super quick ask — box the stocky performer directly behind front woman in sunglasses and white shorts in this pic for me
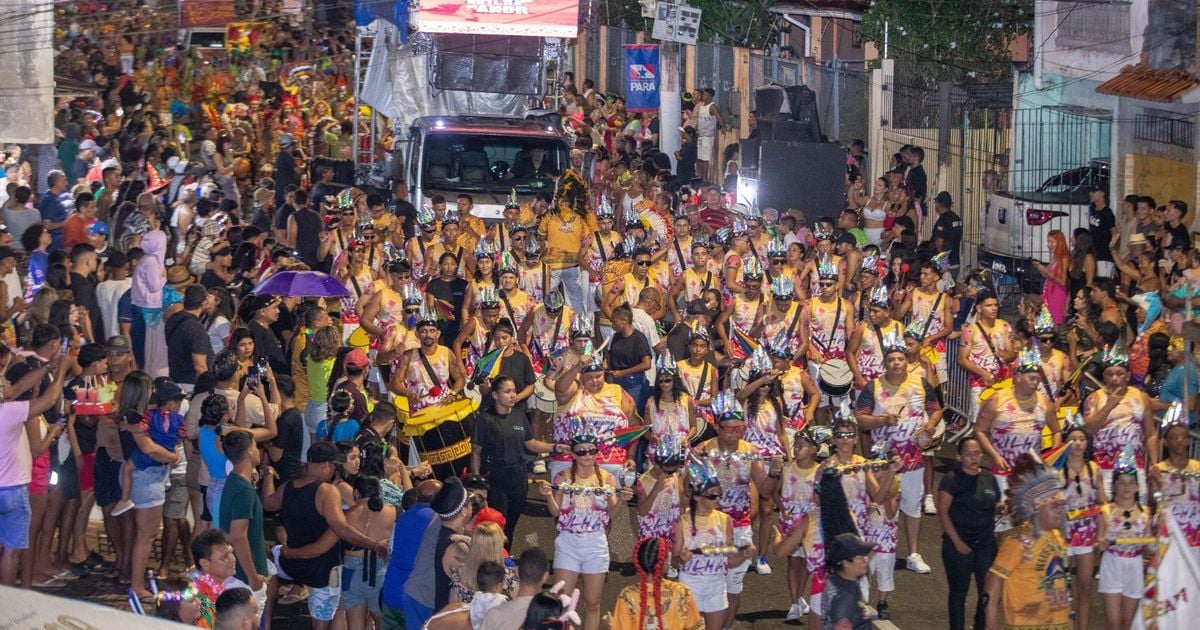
[550,340,642,478]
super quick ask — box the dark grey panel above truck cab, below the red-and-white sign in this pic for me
[433,35,544,95]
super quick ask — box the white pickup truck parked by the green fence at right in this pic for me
[978,158,1109,293]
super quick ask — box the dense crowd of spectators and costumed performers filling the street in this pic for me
[0,5,1200,630]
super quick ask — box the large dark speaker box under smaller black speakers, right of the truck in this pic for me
[758,140,846,214]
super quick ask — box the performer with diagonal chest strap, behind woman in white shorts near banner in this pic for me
[1084,347,1159,502]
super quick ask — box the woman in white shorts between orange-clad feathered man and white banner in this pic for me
[1096,448,1157,630]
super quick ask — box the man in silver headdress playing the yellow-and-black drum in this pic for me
[389,307,466,414]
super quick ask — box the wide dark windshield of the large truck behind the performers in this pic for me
[421,133,568,193]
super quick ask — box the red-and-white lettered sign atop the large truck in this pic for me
[416,0,580,37]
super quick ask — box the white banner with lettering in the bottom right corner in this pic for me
[1133,509,1200,630]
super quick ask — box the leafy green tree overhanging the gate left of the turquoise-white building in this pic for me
[860,0,1033,80]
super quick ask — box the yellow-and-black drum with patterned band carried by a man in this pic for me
[404,398,479,479]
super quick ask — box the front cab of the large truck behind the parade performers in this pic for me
[404,115,570,222]
